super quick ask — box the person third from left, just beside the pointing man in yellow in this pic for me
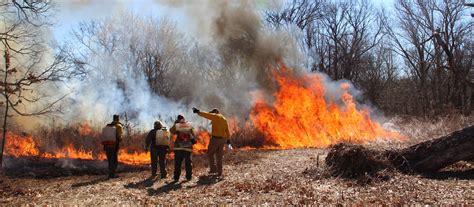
[170,115,196,182]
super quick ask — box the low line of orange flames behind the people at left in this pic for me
[5,124,209,165]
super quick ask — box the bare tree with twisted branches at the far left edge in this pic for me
[0,0,69,166]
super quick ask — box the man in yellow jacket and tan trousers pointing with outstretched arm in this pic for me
[193,108,230,176]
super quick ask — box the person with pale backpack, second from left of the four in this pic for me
[145,121,170,179]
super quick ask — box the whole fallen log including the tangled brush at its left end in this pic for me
[325,126,474,178]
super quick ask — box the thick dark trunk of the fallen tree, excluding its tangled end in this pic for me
[387,125,474,173]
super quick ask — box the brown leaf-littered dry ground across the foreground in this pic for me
[0,149,474,206]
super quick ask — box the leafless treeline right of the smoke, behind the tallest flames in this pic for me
[266,0,474,116]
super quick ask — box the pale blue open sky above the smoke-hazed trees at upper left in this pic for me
[51,0,394,42]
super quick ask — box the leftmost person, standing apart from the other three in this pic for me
[104,115,123,178]
